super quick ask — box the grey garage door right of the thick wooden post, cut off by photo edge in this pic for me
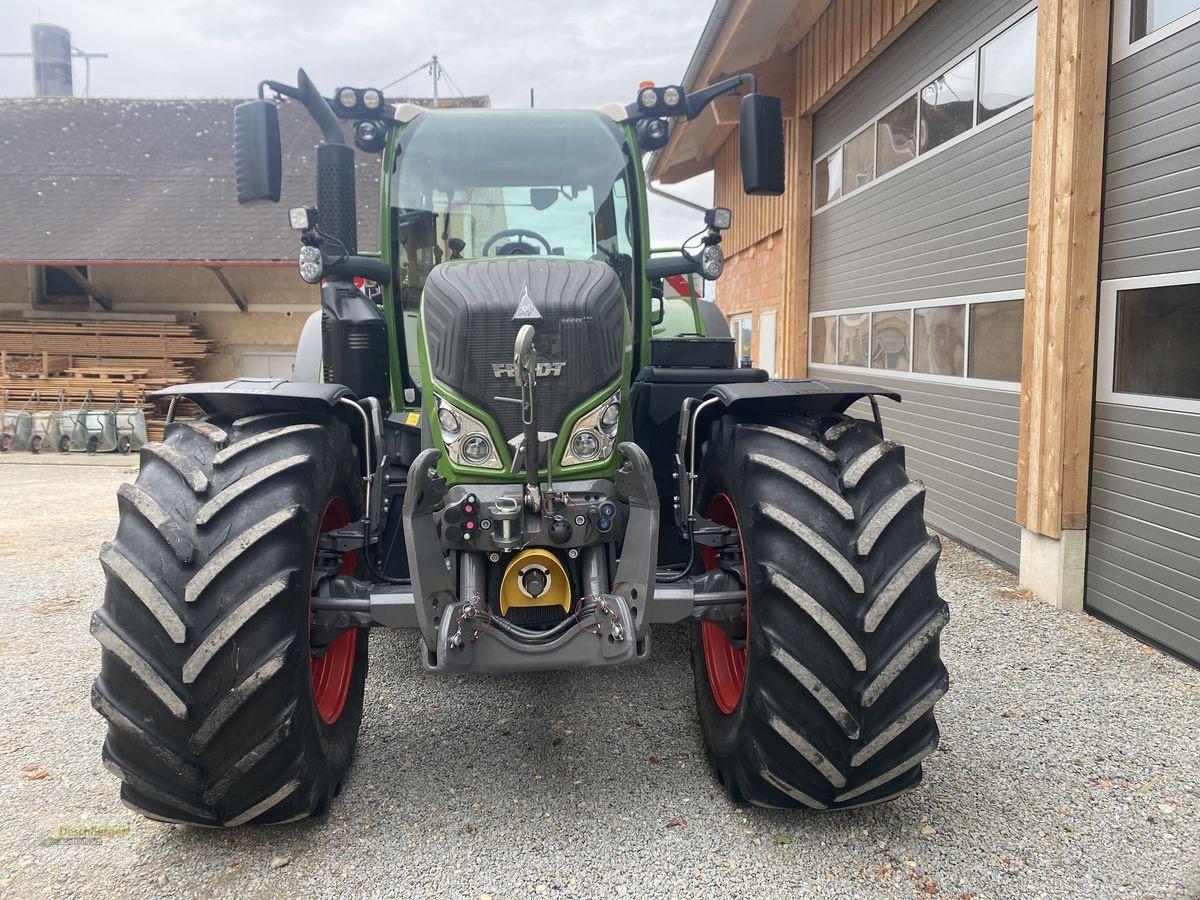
[1085,19,1200,664]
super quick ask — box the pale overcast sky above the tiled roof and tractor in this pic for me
[0,0,712,244]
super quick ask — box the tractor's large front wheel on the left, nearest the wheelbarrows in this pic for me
[91,414,367,826]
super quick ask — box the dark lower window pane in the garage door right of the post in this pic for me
[1112,284,1200,400]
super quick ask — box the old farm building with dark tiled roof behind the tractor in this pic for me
[0,97,488,379]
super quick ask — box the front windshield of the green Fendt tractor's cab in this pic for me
[391,110,635,292]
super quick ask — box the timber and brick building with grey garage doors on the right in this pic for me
[652,0,1200,662]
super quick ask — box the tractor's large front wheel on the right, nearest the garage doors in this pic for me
[692,415,949,809]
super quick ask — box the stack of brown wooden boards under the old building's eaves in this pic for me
[0,319,214,440]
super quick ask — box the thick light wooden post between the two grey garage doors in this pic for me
[1016,0,1111,538]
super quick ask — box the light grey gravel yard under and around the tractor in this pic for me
[0,464,1200,900]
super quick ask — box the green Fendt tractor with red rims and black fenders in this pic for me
[91,71,948,826]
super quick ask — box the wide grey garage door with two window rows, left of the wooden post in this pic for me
[809,0,1037,569]
